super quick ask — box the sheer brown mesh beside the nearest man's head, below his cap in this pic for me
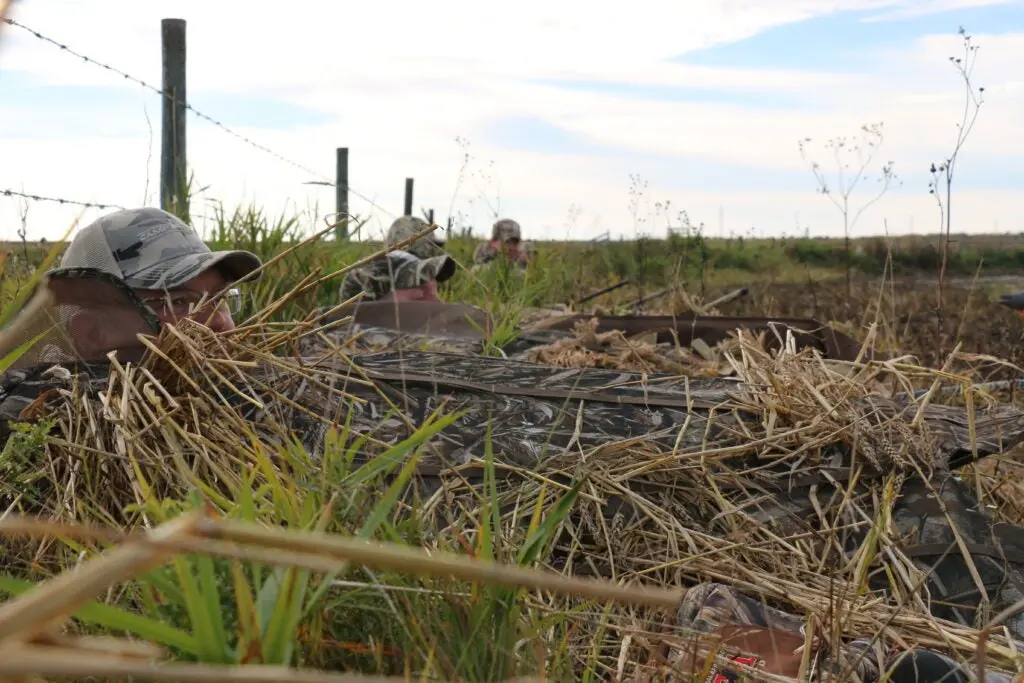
[0,268,160,368]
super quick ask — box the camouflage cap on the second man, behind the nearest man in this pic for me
[340,249,456,301]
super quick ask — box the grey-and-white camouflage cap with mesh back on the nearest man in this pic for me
[50,208,262,290]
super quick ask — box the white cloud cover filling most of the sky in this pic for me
[0,0,1024,245]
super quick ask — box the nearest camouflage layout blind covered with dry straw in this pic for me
[3,301,1024,676]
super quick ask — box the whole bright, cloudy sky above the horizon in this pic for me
[0,0,1024,240]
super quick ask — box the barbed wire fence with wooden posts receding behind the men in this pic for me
[0,17,433,246]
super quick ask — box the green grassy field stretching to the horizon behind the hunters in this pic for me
[8,208,1024,365]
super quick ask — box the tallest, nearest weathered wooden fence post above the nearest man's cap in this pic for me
[160,19,188,219]
